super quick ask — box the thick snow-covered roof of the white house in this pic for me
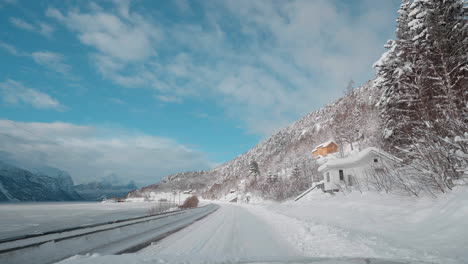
[318,147,401,172]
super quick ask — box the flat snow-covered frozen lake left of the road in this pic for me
[0,202,156,239]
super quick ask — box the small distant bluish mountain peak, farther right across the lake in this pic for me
[75,173,137,201]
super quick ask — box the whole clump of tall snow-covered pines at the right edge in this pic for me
[375,0,468,192]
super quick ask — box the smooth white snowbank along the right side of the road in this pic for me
[248,188,468,263]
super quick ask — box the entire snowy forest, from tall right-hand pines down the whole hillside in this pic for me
[128,0,468,201]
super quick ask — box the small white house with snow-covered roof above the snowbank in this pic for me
[318,147,401,191]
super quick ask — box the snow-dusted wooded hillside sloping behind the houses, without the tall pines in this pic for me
[129,81,381,199]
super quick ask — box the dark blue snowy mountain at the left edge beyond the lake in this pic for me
[0,161,81,202]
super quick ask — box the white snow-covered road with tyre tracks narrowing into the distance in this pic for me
[141,204,298,261]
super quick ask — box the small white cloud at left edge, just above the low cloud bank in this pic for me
[0,79,64,110]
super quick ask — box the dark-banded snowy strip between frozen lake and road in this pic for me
[0,204,219,264]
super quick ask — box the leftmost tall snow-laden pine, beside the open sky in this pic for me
[374,0,418,159]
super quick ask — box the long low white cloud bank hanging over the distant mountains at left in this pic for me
[0,120,213,184]
